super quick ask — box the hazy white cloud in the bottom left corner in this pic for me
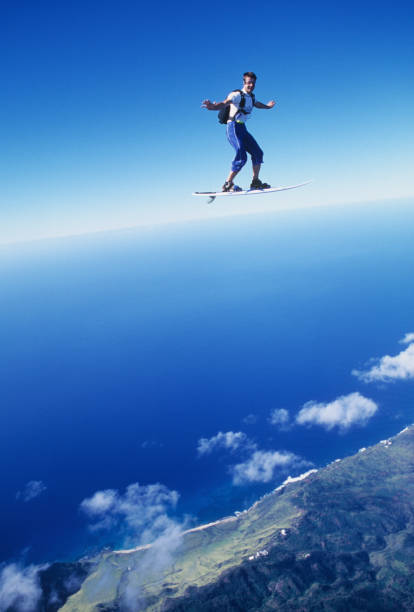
[0,563,46,612]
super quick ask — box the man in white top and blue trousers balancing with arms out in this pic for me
[202,72,276,191]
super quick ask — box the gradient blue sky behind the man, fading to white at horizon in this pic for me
[0,0,414,242]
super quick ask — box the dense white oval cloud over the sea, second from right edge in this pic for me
[296,393,378,429]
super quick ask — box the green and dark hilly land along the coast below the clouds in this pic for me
[43,427,414,612]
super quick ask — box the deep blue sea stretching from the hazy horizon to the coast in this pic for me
[0,200,414,562]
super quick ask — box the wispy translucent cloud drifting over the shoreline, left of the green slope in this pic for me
[80,483,179,542]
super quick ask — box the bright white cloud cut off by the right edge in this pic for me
[352,333,414,383]
